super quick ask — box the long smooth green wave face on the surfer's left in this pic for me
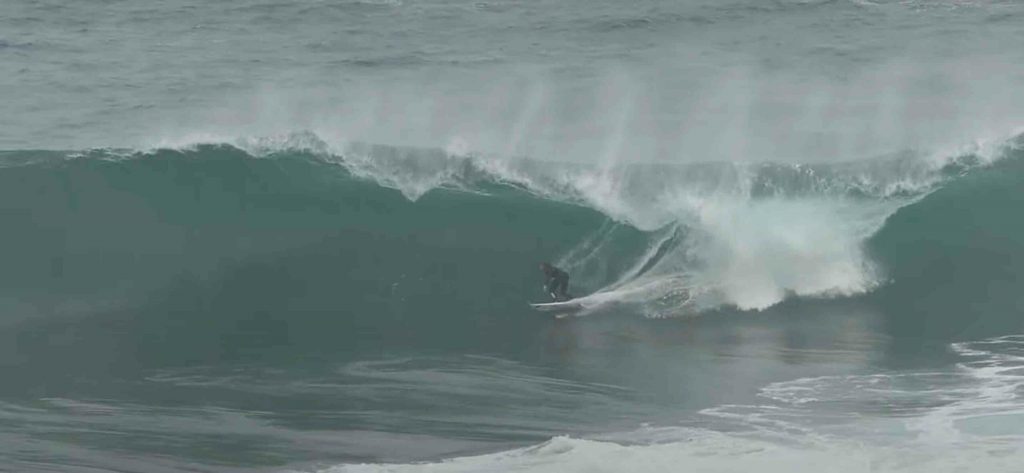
[0,147,614,372]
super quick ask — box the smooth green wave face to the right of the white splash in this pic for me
[869,152,1024,339]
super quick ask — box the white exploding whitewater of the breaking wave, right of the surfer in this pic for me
[548,165,923,309]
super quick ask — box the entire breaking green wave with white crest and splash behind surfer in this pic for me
[0,140,1024,373]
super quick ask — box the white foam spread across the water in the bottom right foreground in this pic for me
[309,336,1024,473]
